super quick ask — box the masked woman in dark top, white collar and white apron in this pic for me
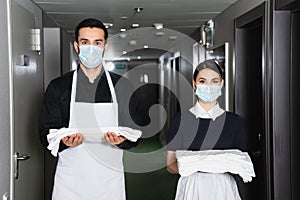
[167,60,245,200]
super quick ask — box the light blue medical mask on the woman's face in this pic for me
[195,85,222,103]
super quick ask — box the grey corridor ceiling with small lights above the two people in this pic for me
[32,0,237,60]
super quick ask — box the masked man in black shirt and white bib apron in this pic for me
[39,19,139,200]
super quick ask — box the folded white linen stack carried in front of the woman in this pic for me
[176,149,255,183]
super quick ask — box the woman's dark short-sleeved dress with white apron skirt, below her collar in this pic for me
[167,111,246,200]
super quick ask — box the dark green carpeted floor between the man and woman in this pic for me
[124,136,179,200]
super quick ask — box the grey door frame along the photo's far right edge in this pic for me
[272,0,300,200]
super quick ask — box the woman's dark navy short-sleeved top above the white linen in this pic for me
[167,111,246,151]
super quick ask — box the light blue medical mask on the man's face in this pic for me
[79,45,104,68]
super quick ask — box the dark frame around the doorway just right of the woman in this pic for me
[233,1,273,200]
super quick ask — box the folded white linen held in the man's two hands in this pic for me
[47,127,142,156]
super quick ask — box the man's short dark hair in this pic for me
[75,18,108,42]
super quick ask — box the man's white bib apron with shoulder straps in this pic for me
[52,70,126,200]
